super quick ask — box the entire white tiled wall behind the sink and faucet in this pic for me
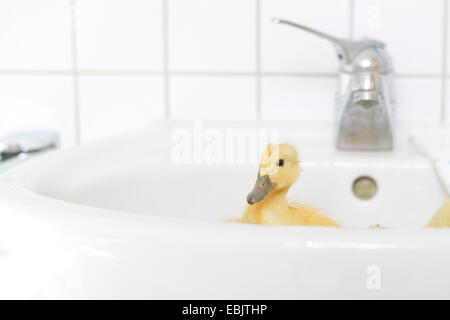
[0,0,450,145]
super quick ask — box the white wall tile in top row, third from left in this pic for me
[168,0,256,71]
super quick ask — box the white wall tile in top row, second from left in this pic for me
[76,0,163,71]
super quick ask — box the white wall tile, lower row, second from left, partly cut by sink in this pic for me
[79,75,164,142]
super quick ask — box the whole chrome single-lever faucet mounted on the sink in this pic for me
[273,19,395,150]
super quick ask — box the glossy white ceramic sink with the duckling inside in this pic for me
[0,123,450,299]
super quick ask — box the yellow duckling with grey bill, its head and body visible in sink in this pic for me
[242,144,337,226]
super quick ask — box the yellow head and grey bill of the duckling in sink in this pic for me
[247,143,300,205]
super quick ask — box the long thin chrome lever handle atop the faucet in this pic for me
[272,18,385,64]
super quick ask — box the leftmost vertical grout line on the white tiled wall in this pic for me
[70,0,81,145]
